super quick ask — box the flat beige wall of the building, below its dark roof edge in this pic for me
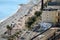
[42,9,58,23]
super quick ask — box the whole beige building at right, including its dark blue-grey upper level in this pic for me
[41,0,60,23]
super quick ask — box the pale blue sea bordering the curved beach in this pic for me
[0,0,29,20]
